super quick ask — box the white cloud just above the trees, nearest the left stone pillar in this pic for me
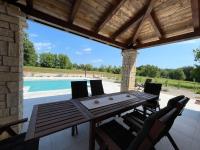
[34,42,55,52]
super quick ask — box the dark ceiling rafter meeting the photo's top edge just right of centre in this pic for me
[95,0,126,33]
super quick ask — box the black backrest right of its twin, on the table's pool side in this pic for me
[90,80,104,96]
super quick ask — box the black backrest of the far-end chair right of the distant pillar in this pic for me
[144,83,162,97]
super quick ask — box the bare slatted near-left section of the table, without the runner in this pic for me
[25,100,90,141]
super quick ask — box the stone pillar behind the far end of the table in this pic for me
[121,49,137,92]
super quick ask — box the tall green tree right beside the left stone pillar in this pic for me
[23,33,37,66]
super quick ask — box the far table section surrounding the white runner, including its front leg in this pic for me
[72,91,157,150]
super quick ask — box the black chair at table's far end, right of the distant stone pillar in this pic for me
[142,83,162,115]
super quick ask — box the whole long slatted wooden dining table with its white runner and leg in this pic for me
[25,91,157,150]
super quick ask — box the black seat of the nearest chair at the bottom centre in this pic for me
[97,120,135,150]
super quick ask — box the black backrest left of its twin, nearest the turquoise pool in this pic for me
[71,81,88,99]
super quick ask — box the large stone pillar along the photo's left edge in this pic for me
[0,0,25,136]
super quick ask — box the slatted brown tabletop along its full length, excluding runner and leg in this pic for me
[25,92,156,141]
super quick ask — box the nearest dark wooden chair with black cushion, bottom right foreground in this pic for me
[96,107,180,150]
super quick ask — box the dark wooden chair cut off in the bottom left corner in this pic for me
[0,118,39,150]
